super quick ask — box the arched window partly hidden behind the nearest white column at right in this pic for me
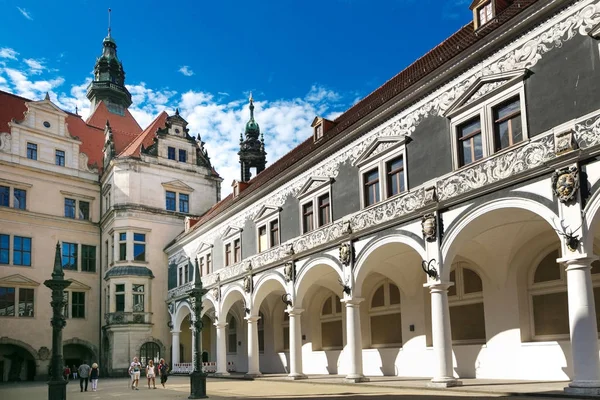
[529,249,600,340]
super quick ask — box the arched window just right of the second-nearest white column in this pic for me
[448,262,486,344]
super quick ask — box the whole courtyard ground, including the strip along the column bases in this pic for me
[0,376,580,400]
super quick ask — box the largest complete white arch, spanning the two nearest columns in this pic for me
[440,197,560,281]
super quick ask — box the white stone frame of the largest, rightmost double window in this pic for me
[450,78,529,170]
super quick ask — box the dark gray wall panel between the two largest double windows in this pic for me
[406,116,452,188]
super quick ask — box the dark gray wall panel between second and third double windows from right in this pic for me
[331,161,360,221]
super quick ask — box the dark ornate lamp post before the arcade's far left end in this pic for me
[188,260,208,399]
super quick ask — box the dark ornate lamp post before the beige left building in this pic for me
[44,243,71,400]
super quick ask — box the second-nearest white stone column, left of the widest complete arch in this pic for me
[426,282,461,387]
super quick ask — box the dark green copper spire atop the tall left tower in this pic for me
[87,9,131,115]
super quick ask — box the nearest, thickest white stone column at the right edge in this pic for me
[558,254,600,395]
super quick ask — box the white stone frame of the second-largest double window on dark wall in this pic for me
[357,140,408,208]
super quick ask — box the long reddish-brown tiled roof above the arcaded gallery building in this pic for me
[184,0,538,236]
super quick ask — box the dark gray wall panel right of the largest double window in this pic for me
[525,35,600,136]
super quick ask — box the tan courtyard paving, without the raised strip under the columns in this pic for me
[0,376,576,400]
